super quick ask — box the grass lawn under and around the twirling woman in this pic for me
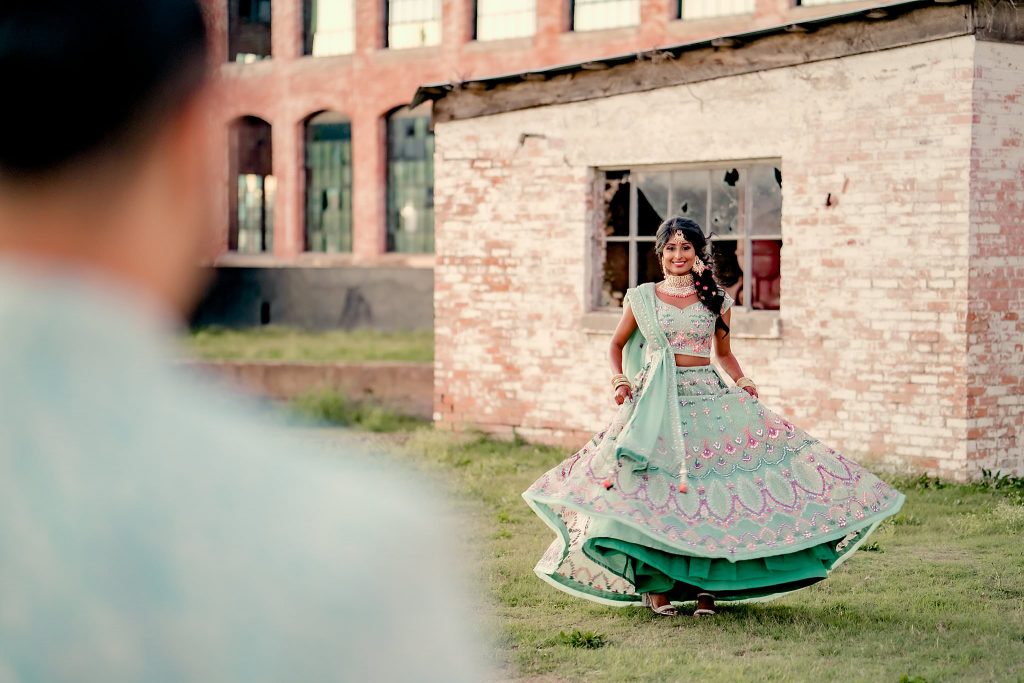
[370,428,1024,683]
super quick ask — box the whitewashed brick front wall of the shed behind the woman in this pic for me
[434,37,974,477]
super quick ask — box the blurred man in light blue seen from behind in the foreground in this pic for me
[0,0,480,683]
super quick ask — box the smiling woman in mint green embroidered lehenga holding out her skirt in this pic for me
[523,217,904,615]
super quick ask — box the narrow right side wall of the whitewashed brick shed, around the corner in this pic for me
[967,42,1024,474]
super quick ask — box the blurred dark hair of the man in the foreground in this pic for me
[0,0,208,180]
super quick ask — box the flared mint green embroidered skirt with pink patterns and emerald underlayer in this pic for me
[523,366,905,604]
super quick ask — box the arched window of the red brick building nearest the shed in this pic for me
[387,104,434,253]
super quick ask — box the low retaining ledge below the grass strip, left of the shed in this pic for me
[188,360,434,420]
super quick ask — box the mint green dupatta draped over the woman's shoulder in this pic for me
[615,283,686,480]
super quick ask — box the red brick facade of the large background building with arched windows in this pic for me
[202,0,888,266]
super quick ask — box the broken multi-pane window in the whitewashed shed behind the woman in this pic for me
[596,163,782,310]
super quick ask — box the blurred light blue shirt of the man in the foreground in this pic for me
[0,264,486,683]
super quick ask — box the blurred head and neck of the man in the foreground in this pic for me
[0,0,209,309]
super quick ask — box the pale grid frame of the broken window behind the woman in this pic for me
[589,158,784,315]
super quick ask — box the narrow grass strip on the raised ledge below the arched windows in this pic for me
[184,327,434,362]
